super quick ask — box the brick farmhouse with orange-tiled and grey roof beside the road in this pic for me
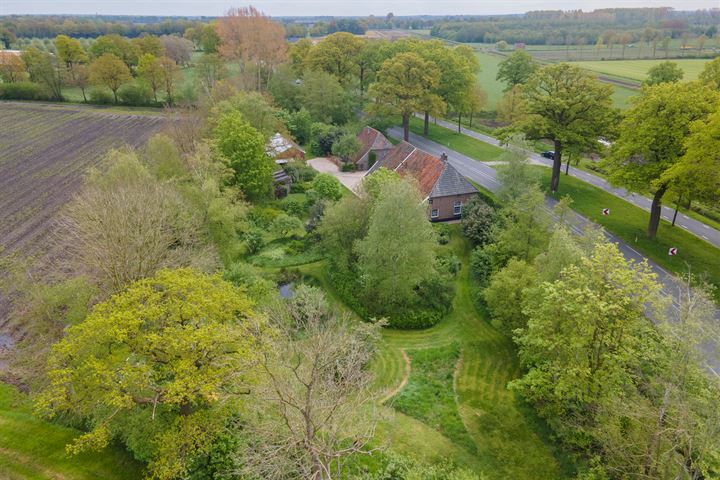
[366,142,478,222]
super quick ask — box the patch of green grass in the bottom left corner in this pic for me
[0,384,142,480]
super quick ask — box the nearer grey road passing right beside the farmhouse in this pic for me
[388,127,720,371]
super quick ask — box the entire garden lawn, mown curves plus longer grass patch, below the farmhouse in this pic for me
[300,225,571,480]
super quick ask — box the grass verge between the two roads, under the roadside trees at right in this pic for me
[536,166,720,300]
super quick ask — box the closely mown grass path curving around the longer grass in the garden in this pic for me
[373,231,569,480]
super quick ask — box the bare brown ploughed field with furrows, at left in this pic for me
[0,102,163,253]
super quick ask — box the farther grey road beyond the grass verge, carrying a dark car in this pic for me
[420,118,720,248]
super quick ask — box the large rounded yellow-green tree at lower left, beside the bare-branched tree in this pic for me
[36,269,266,479]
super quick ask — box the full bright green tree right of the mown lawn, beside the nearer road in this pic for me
[511,243,663,447]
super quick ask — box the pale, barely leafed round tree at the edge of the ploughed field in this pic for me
[58,152,211,293]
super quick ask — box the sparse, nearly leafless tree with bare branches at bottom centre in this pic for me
[239,286,380,480]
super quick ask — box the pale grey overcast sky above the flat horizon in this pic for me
[0,0,720,16]
